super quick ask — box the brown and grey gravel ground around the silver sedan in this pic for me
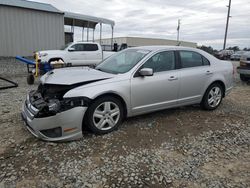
[0,59,250,188]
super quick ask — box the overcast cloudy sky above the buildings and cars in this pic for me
[33,0,250,49]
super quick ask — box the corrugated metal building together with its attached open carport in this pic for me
[0,0,115,57]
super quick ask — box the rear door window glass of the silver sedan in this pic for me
[180,51,203,68]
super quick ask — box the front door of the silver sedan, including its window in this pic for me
[131,51,179,114]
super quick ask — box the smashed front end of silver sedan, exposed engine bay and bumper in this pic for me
[22,84,90,141]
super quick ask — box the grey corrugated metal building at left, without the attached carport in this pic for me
[0,0,64,56]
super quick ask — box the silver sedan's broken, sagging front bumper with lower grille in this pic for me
[21,95,87,141]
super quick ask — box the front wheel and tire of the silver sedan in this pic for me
[84,96,124,134]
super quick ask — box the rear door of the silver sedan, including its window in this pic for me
[178,51,213,105]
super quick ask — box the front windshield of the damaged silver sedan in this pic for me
[96,49,150,74]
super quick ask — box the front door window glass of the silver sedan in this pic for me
[143,51,175,72]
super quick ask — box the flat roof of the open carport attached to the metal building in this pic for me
[64,12,115,27]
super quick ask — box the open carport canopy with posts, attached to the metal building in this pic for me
[64,12,115,49]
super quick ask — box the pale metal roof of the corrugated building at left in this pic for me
[0,0,63,14]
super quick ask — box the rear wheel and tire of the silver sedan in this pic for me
[201,83,224,110]
